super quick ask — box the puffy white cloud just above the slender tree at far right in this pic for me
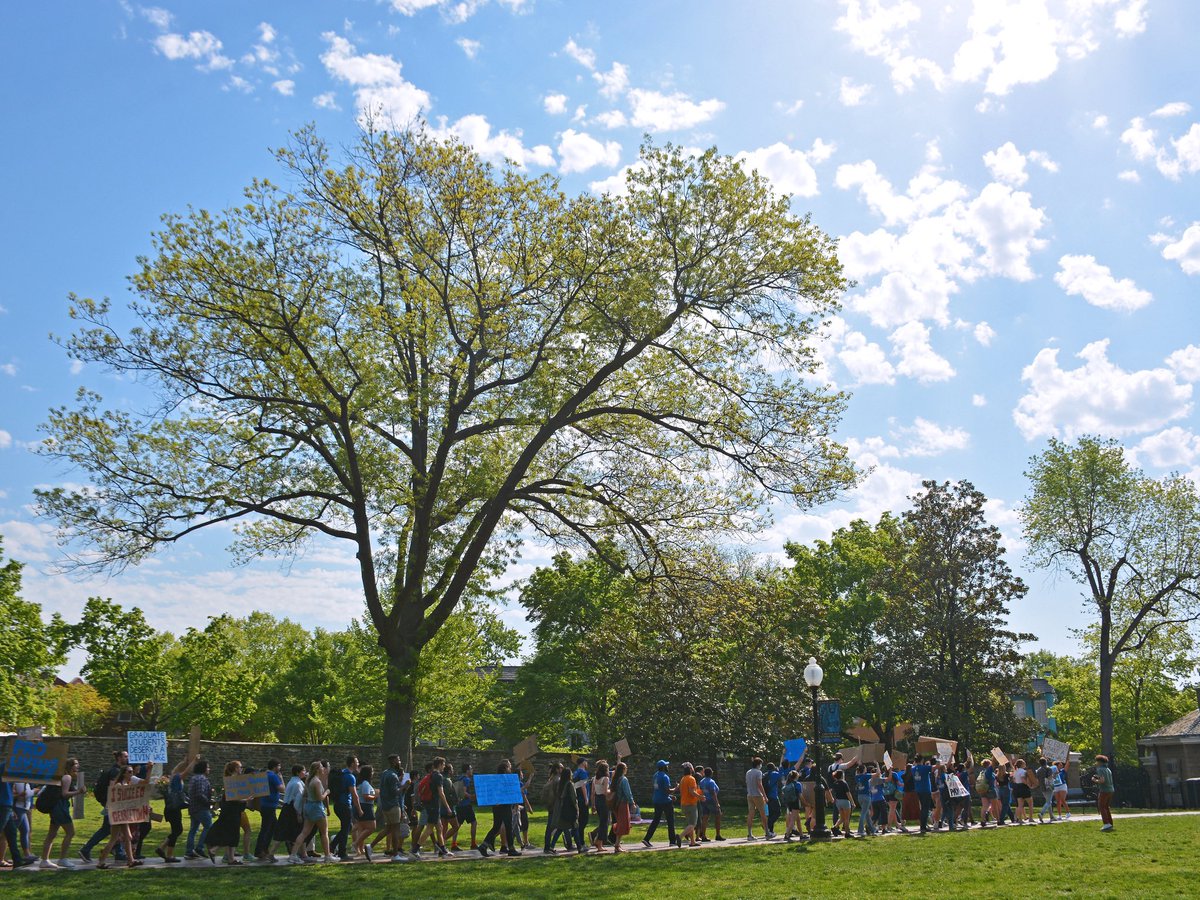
[1013,340,1192,440]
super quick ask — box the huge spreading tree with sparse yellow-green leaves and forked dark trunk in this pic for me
[40,123,851,748]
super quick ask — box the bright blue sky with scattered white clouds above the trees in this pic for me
[0,0,1200,672]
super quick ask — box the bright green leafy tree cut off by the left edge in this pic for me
[0,538,66,730]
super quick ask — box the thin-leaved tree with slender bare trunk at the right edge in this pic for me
[1021,437,1200,757]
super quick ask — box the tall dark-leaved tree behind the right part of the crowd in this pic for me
[884,481,1034,746]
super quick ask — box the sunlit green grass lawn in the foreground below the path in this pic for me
[0,816,1200,900]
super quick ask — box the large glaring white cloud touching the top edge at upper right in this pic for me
[835,0,1145,96]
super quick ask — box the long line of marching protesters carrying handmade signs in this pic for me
[0,750,1114,869]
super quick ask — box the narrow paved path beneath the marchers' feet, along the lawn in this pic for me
[11,811,1200,876]
